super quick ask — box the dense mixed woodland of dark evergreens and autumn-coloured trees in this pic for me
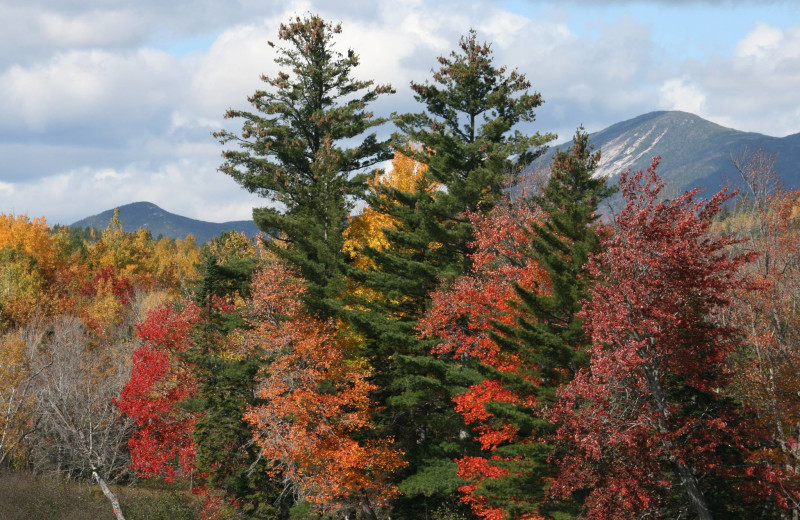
[0,15,800,520]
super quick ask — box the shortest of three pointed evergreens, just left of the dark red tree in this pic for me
[474,128,616,518]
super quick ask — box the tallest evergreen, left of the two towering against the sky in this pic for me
[215,15,392,316]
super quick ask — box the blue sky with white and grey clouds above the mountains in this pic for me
[0,0,800,224]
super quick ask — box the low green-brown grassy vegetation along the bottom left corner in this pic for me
[0,473,201,520]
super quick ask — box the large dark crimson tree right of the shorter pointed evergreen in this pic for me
[550,158,796,519]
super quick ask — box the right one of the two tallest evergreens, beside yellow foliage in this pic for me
[349,31,553,518]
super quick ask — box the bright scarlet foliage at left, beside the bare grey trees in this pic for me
[117,304,198,481]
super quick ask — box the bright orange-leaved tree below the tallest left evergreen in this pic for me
[241,263,403,520]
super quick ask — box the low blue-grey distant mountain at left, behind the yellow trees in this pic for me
[70,202,259,244]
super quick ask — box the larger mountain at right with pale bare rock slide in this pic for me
[533,111,800,203]
